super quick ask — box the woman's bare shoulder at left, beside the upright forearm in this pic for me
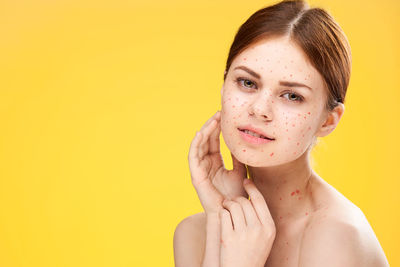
[174,212,207,267]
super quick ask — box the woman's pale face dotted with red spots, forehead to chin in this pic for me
[221,35,326,167]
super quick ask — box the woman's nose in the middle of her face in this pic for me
[248,90,273,121]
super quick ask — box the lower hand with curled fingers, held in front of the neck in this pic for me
[220,179,276,267]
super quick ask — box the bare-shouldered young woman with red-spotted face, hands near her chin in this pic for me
[174,1,389,267]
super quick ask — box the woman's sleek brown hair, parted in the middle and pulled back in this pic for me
[224,0,351,111]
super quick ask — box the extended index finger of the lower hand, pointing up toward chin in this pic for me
[243,179,274,227]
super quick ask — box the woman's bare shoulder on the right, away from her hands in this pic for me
[299,177,389,267]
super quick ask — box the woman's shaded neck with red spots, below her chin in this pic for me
[247,152,316,226]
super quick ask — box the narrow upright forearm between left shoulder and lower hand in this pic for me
[201,213,221,267]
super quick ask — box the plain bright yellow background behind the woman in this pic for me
[0,0,400,267]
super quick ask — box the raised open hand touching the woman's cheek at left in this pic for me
[188,111,248,215]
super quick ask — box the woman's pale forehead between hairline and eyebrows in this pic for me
[232,37,324,91]
